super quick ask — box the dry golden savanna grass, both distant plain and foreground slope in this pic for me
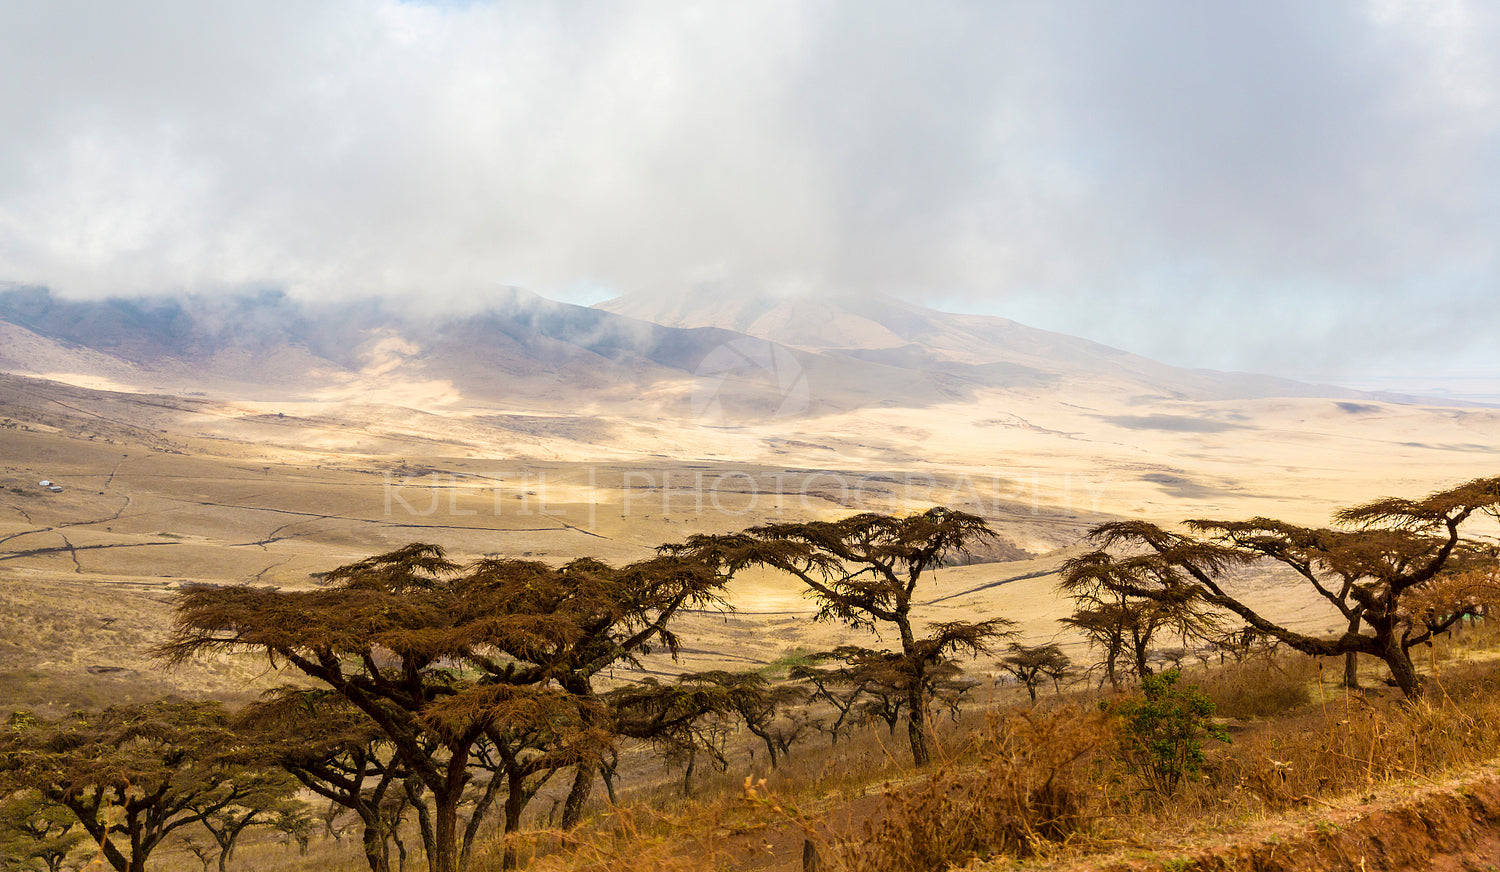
[0,348,1500,870]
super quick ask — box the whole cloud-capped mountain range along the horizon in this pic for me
[0,282,1392,414]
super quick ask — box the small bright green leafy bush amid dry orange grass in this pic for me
[1110,669,1229,797]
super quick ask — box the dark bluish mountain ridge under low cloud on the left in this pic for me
[0,288,756,401]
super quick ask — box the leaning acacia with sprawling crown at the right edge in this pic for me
[1067,477,1500,698]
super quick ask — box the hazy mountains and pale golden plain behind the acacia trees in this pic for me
[0,285,1500,714]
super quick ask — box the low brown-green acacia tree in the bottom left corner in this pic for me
[0,701,286,872]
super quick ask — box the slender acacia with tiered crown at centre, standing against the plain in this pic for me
[672,507,1011,765]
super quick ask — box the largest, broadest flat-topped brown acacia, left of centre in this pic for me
[159,543,726,872]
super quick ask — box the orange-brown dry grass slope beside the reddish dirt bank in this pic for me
[489,627,1500,872]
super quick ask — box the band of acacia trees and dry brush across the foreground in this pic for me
[0,479,1500,872]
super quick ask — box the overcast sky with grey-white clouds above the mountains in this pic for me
[0,0,1500,378]
